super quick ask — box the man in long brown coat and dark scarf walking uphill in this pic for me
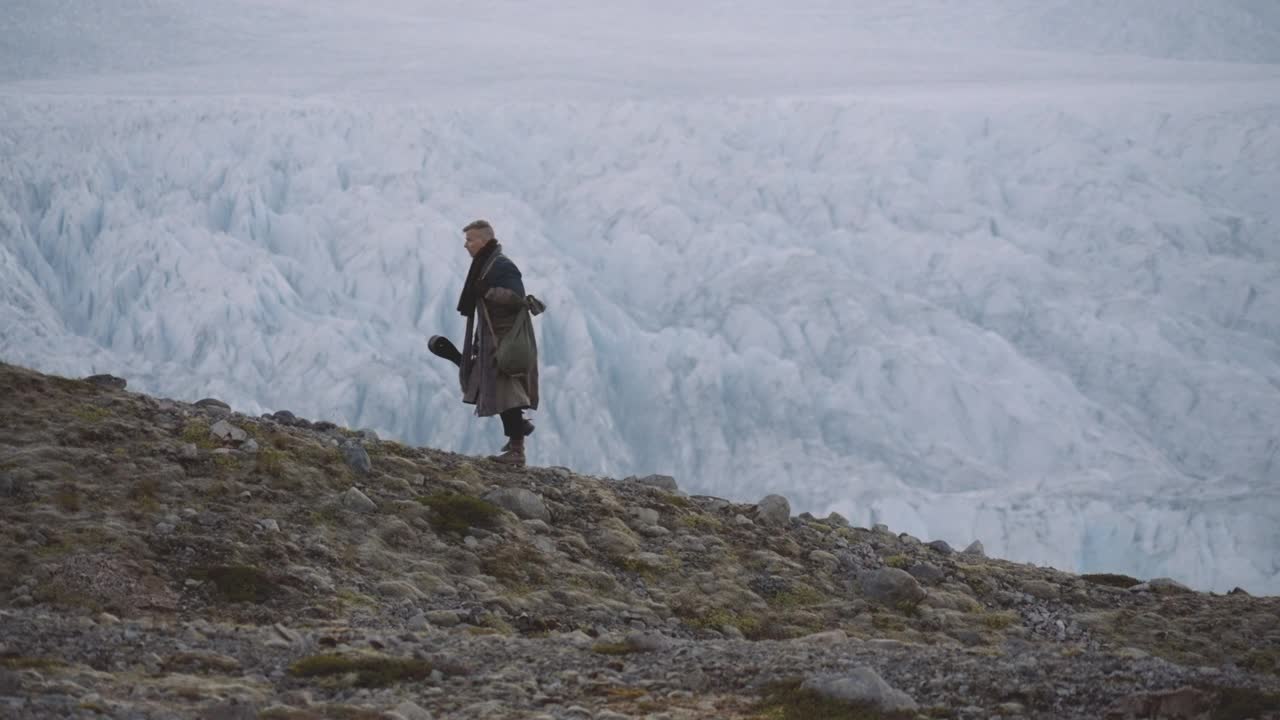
[458,220,538,468]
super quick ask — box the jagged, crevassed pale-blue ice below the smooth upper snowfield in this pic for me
[0,97,1280,593]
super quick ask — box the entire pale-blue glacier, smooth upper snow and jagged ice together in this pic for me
[0,0,1280,593]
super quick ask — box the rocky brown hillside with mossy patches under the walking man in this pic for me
[0,365,1280,720]
